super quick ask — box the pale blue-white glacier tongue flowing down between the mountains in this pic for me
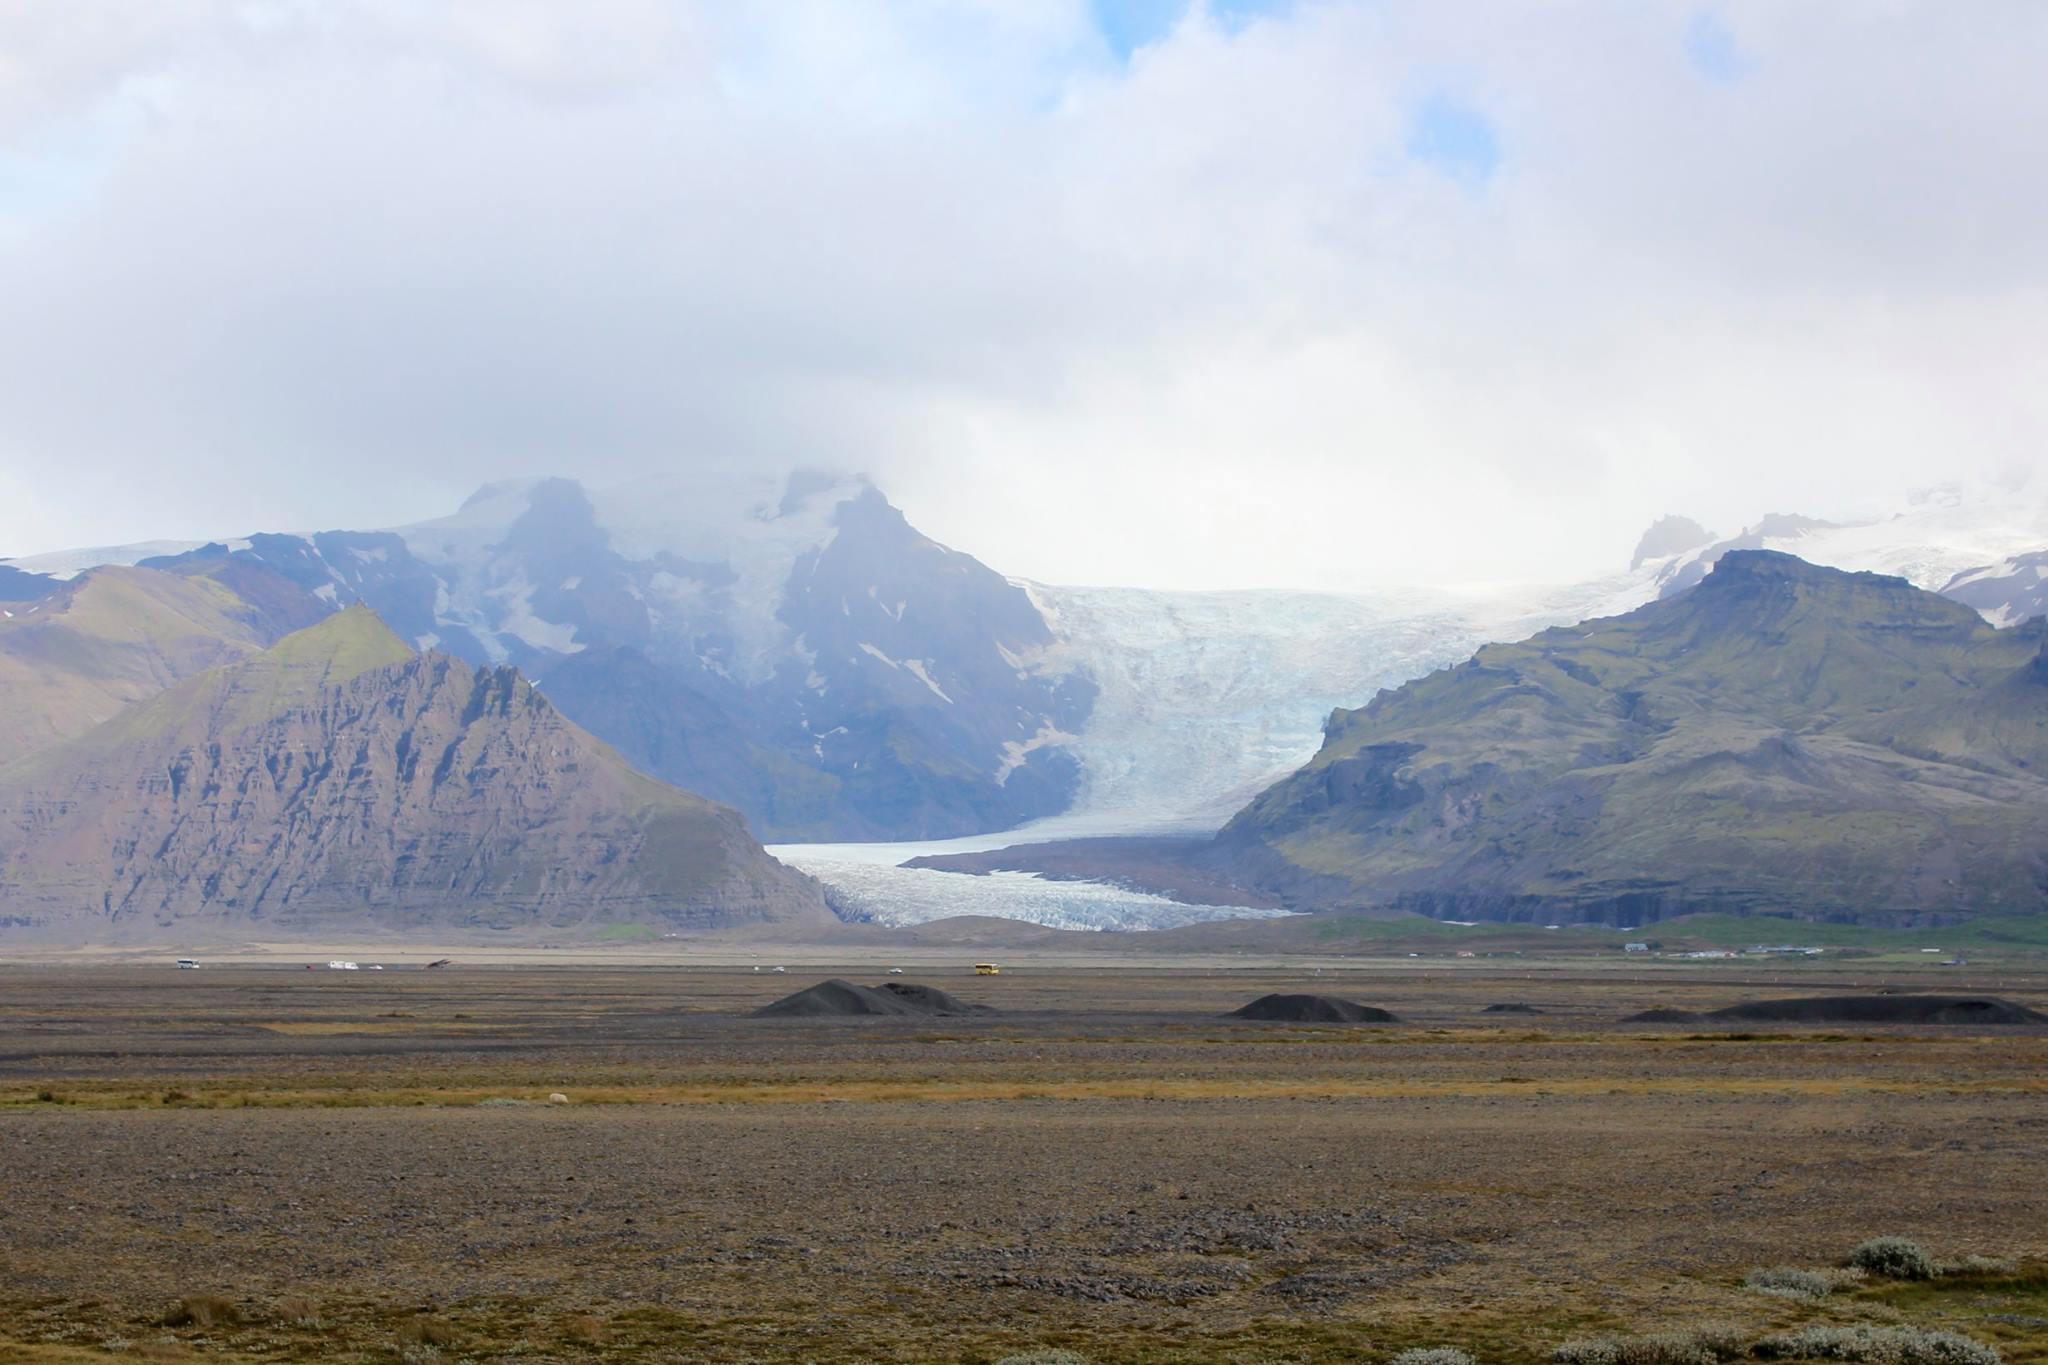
[770,567,1655,929]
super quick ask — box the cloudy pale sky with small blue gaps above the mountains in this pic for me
[0,0,2048,587]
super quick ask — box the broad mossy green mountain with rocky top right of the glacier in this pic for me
[1208,551,2048,923]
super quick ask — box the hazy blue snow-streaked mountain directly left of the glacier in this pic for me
[125,475,1094,839]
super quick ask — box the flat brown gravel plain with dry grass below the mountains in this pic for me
[0,950,2048,1365]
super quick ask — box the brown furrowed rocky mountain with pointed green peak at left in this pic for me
[0,608,829,939]
